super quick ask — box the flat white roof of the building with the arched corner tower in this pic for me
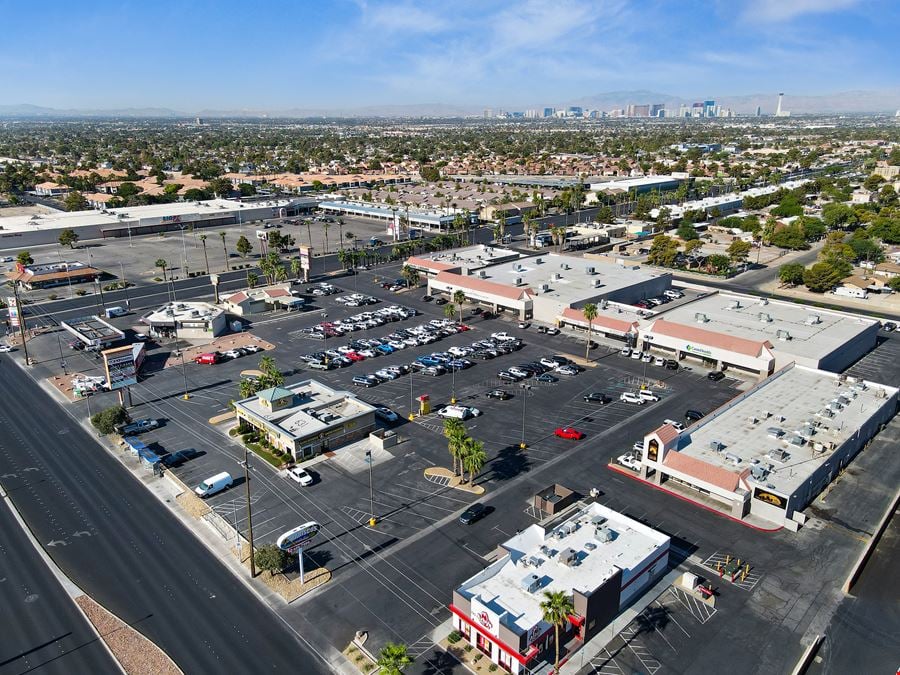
[679,365,897,495]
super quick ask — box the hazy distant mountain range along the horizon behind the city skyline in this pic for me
[0,88,900,119]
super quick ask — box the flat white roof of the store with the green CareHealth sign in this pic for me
[654,293,878,365]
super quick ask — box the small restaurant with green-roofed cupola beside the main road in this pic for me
[234,380,375,461]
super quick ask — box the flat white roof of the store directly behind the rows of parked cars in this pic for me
[478,253,666,303]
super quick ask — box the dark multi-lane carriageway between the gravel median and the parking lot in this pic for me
[0,356,329,673]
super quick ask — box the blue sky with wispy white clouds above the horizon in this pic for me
[0,0,900,112]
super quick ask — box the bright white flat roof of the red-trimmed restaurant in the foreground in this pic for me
[459,504,669,634]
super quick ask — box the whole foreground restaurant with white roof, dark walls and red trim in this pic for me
[450,503,670,674]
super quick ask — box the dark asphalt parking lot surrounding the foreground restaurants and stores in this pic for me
[21,268,900,673]
